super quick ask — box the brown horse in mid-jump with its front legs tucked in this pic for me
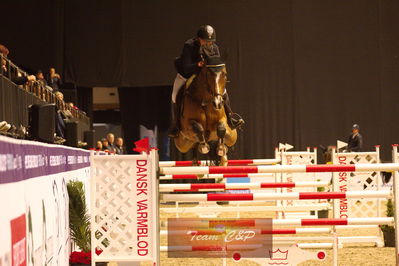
[174,59,237,165]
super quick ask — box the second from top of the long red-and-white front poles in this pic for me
[161,191,391,202]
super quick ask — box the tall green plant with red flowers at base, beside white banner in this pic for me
[67,181,106,266]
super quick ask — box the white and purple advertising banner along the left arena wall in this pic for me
[0,136,90,266]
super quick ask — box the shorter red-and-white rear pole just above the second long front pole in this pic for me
[159,182,328,192]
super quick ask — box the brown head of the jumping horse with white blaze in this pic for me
[202,60,227,110]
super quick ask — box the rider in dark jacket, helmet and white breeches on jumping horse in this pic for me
[169,25,244,137]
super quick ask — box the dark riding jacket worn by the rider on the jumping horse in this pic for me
[175,38,220,79]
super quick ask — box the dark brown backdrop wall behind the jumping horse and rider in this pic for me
[0,0,399,158]
